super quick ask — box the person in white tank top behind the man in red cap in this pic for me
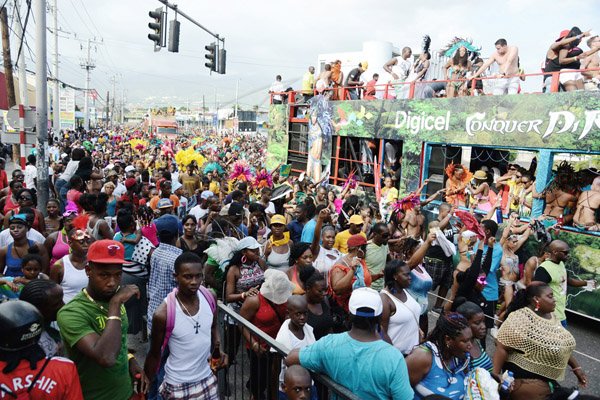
[50,228,91,304]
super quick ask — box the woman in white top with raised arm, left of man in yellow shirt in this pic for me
[310,208,342,282]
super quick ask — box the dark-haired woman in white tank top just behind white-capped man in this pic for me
[381,260,421,355]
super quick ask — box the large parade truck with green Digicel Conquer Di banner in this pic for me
[267,72,600,319]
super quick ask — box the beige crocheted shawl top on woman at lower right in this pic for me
[497,307,576,380]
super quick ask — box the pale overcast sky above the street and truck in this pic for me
[13,0,600,109]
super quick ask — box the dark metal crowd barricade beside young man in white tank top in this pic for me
[218,301,359,400]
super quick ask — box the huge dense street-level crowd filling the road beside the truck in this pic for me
[0,124,600,400]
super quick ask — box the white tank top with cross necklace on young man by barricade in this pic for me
[165,291,213,385]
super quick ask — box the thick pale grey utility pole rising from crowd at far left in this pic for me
[32,0,49,215]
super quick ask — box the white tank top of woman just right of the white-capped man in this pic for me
[381,289,421,354]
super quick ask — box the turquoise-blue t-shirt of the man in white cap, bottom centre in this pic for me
[300,332,414,400]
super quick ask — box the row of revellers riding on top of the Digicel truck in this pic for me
[269,26,600,104]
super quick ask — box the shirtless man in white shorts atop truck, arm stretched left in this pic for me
[471,39,519,96]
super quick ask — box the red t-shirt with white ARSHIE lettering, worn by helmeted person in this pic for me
[0,357,83,400]
